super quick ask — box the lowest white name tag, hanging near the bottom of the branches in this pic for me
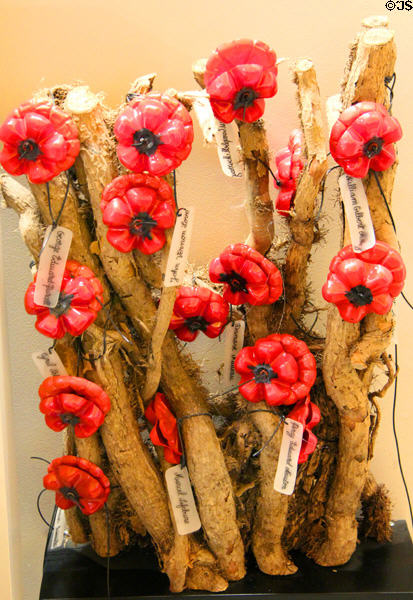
[165,465,201,535]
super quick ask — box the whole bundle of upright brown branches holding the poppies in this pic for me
[1,18,397,592]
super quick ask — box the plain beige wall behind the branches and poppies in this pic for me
[0,0,413,600]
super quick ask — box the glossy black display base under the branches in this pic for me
[40,521,413,600]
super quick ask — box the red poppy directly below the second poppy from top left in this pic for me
[100,173,175,254]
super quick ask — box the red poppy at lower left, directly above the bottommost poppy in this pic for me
[39,375,110,438]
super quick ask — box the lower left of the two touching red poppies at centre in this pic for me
[169,286,229,342]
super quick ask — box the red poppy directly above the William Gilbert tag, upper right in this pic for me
[330,102,402,177]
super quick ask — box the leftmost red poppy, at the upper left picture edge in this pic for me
[0,100,80,183]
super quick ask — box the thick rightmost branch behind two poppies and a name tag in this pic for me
[315,27,396,566]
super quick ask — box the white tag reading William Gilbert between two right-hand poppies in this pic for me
[338,175,376,252]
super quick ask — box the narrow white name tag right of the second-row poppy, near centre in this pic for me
[163,207,195,287]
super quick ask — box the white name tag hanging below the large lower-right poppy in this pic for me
[274,419,304,496]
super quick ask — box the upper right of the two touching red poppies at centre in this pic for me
[209,244,283,305]
